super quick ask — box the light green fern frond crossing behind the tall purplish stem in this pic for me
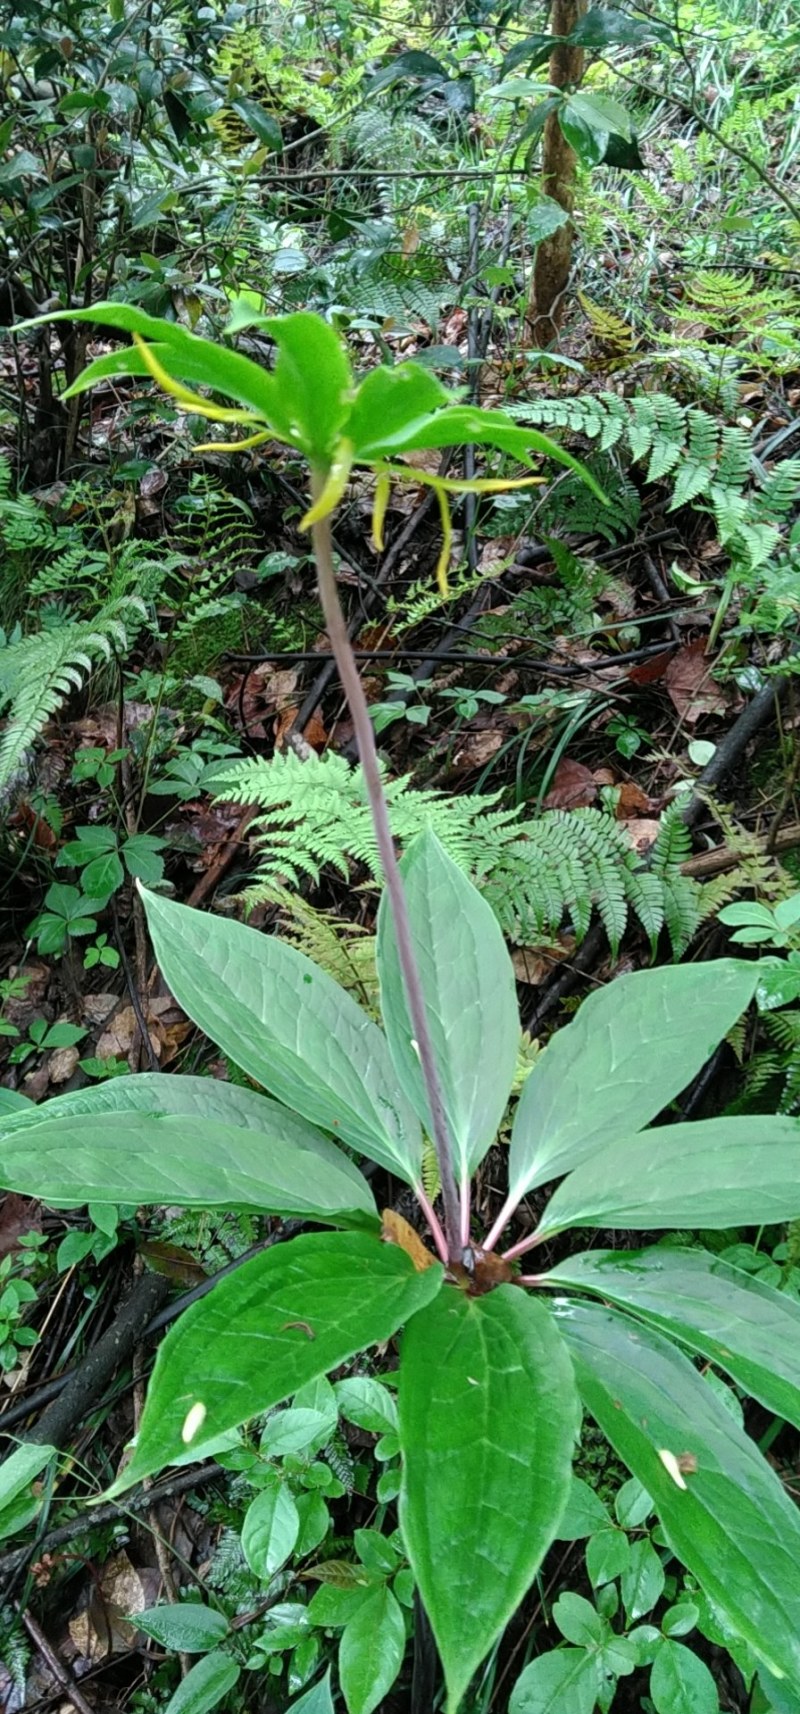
[216,751,701,953]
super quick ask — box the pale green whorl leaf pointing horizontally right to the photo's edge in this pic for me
[540,1114,800,1236]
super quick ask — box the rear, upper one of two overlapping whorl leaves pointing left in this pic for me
[0,1071,373,1210]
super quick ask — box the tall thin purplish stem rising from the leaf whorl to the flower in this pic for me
[312,490,463,1262]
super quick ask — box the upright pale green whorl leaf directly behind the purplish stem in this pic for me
[377,831,519,1181]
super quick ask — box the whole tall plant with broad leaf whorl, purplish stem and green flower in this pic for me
[7,305,800,1714]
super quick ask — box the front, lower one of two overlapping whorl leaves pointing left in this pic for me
[0,1110,377,1226]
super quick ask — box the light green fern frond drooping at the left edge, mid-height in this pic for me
[0,596,146,792]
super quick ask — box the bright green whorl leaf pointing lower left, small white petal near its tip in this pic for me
[111,1232,442,1493]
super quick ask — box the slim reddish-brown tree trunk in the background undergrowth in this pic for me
[526,0,588,346]
